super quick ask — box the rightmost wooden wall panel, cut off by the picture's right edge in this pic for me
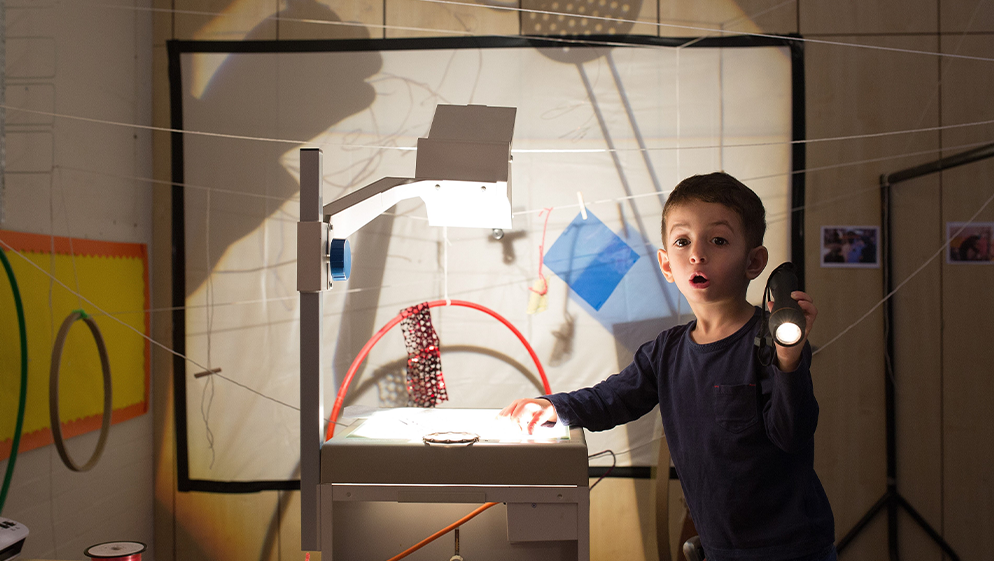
[939,35,994,559]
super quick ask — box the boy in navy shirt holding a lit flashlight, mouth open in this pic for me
[501,173,836,561]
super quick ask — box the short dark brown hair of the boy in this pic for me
[662,171,766,248]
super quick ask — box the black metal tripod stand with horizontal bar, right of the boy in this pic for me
[836,144,994,561]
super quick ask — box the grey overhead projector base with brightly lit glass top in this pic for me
[319,408,590,561]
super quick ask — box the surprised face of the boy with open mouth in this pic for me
[658,201,769,304]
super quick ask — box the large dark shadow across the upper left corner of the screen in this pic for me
[183,0,383,296]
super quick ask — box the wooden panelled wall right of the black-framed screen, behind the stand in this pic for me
[800,0,994,561]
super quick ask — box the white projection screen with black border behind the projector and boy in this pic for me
[169,37,803,492]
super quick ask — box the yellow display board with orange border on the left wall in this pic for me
[0,230,151,460]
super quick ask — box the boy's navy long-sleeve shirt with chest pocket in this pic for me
[546,308,835,561]
